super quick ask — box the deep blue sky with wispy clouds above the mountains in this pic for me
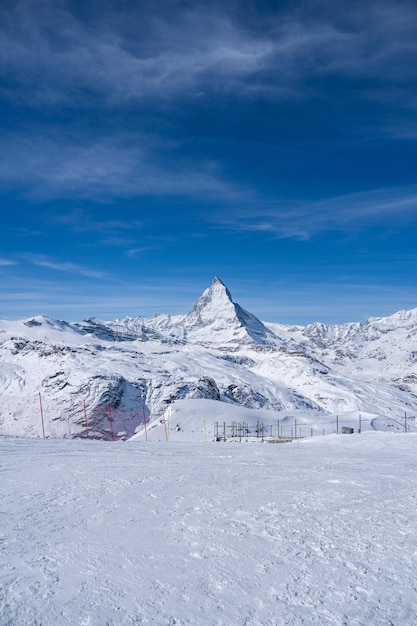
[0,0,417,324]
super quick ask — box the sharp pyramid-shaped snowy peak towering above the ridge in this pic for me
[183,276,282,345]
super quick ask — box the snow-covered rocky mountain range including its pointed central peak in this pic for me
[0,277,417,438]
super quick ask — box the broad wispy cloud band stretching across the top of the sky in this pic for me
[0,0,417,106]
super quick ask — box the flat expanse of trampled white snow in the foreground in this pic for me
[0,433,417,626]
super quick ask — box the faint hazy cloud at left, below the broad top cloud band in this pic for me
[0,132,241,200]
